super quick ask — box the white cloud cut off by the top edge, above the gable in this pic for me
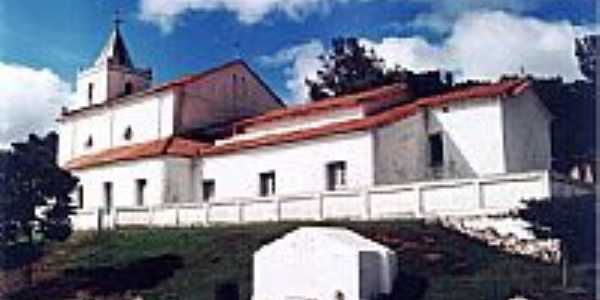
[140,0,358,32]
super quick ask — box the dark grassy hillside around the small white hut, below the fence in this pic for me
[10,222,592,300]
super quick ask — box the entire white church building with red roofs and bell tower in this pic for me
[58,22,576,228]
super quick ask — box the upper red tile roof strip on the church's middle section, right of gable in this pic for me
[234,84,406,130]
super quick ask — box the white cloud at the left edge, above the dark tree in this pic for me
[0,62,72,147]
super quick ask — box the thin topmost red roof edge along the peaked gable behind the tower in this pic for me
[61,59,285,118]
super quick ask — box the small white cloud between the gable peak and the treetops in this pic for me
[261,40,325,103]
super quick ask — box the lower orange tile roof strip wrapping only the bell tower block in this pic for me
[65,137,211,170]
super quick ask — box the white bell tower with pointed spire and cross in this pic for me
[77,14,152,106]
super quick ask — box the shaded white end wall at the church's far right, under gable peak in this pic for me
[502,89,552,172]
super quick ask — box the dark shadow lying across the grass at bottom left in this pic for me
[9,254,183,300]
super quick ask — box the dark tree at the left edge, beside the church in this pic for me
[0,133,78,296]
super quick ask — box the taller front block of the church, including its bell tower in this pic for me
[58,27,283,210]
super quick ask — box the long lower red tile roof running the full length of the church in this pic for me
[65,80,528,170]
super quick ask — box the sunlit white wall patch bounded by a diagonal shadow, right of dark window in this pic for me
[428,98,506,176]
